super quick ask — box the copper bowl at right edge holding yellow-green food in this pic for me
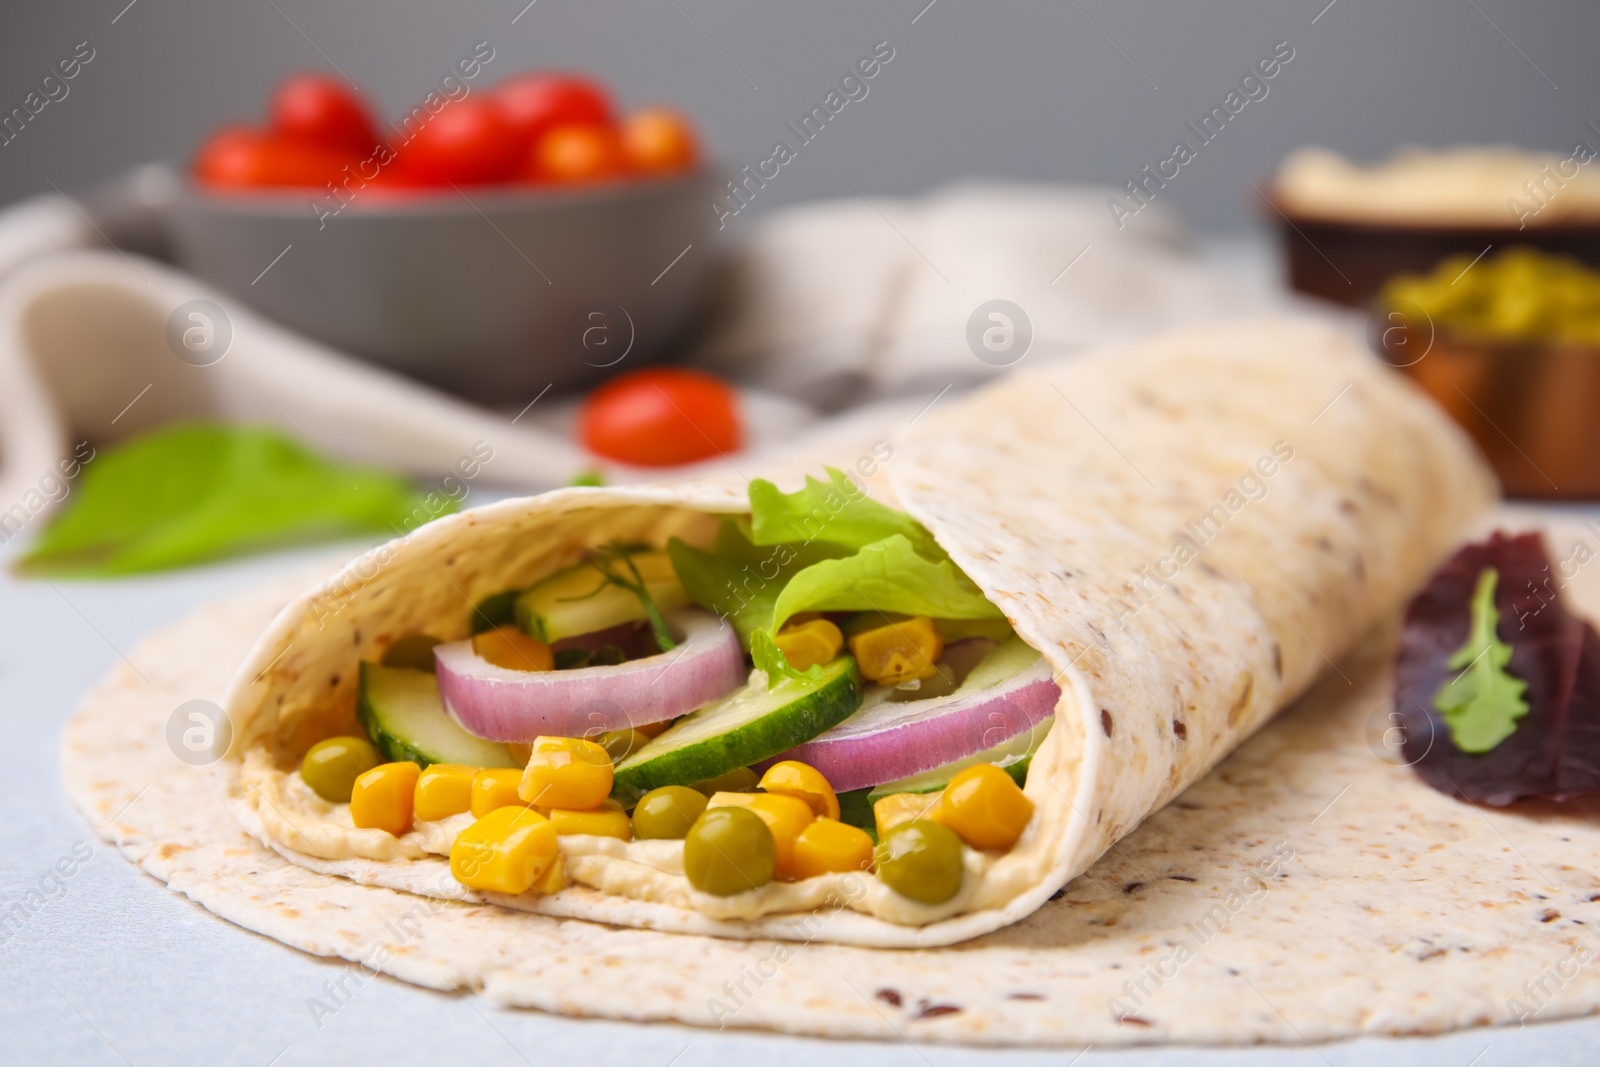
[1374,314,1600,501]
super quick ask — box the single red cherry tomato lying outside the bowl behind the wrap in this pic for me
[578,366,742,467]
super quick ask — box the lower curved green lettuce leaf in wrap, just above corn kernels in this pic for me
[768,534,1003,633]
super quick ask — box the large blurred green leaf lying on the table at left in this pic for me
[16,422,441,577]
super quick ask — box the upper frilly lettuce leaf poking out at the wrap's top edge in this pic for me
[750,467,946,560]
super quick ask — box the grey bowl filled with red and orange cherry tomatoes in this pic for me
[171,72,714,403]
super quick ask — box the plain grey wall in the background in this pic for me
[0,0,1600,230]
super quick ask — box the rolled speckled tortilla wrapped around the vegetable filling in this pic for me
[209,320,1493,947]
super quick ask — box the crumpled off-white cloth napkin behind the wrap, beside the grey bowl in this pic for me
[0,184,1275,514]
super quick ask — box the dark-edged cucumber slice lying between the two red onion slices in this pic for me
[613,656,861,801]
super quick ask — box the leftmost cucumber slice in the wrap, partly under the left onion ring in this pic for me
[357,662,518,766]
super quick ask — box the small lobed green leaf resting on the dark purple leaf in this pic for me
[1434,566,1528,753]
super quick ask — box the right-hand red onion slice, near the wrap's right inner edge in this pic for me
[778,649,1061,792]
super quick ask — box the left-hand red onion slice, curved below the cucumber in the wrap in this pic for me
[434,609,747,744]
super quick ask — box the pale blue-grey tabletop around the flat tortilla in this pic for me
[0,233,1600,1067]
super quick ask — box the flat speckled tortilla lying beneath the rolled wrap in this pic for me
[62,511,1600,1049]
